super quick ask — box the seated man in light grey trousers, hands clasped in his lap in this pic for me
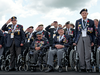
[45,28,71,72]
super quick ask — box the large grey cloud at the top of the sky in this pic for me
[29,0,91,12]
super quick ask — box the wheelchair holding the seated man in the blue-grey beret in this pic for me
[24,48,48,71]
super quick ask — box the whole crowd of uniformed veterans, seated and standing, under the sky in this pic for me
[0,9,100,72]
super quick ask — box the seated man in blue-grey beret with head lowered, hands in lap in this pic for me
[30,32,49,65]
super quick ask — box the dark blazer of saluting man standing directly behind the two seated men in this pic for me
[45,25,59,45]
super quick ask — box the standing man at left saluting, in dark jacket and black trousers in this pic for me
[2,16,25,70]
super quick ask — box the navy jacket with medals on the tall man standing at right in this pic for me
[75,19,95,44]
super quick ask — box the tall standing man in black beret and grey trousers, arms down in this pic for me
[74,9,95,72]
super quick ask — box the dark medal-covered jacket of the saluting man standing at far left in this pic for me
[2,24,25,47]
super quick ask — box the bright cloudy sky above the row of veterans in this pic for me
[0,0,100,29]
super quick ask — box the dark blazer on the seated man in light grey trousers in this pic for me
[53,35,71,50]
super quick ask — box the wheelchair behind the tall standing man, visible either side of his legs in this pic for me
[69,46,96,72]
